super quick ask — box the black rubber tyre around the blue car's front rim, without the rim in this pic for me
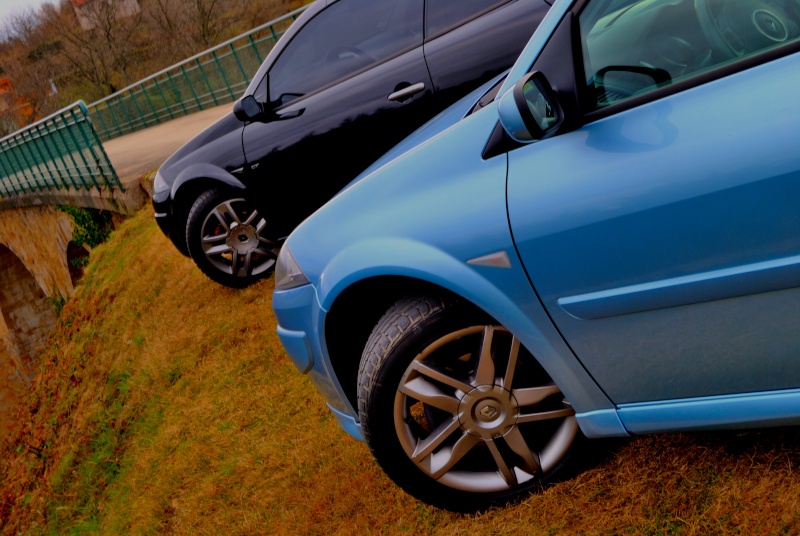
[357,295,581,513]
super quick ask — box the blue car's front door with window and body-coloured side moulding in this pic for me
[507,0,800,404]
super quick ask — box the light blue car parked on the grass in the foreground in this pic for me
[273,0,800,510]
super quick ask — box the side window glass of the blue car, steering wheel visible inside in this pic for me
[579,0,800,109]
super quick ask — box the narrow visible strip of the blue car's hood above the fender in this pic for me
[340,71,508,193]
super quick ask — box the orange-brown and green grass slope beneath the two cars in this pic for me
[0,209,800,535]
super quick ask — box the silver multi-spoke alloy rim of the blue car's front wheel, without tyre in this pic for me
[394,326,578,493]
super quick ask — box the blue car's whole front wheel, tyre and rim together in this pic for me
[358,297,581,512]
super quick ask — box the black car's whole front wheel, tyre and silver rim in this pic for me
[186,188,280,288]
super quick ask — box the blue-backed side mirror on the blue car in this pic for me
[497,71,564,143]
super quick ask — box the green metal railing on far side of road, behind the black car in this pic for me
[89,6,308,140]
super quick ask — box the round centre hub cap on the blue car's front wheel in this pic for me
[458,385,519,439]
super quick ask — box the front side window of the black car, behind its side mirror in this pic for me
[266,0,423,105]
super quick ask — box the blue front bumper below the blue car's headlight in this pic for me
[272,285,364,441]
